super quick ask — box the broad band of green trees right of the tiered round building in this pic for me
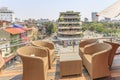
[82,22,120,36]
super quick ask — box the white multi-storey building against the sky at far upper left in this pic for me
[0,7,14,22]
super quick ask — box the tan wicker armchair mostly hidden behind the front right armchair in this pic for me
[79,39,98,58]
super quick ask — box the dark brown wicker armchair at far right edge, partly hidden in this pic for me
[104,41,120,68]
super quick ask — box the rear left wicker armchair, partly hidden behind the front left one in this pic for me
[32,40,55,69]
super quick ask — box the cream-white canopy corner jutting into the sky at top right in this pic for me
[97,0,120,18]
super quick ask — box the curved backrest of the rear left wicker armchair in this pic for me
[32,40,54,49]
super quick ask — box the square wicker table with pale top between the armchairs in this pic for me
[60,54,82,77]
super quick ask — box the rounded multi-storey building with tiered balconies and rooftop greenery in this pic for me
[57,11,82,44]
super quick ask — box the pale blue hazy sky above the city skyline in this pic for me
[0,0,117,20]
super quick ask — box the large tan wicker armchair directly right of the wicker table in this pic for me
[83,43,112,79]
